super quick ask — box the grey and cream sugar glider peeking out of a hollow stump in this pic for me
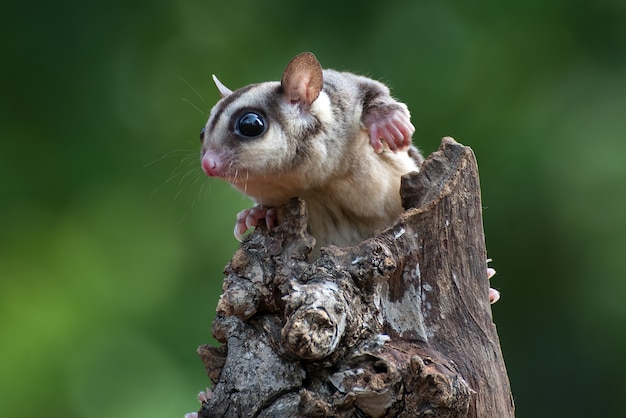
[200,52,423,254]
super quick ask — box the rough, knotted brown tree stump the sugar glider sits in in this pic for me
[198,138,514,417]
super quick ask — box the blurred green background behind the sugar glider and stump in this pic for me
[0,0,626,418]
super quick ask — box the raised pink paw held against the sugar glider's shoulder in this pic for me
[363,103,415,154]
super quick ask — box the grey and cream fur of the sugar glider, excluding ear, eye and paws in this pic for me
[202,55,421,251]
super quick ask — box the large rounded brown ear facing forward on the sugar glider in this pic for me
[280,52,324,108]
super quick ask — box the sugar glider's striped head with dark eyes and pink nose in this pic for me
[200,52,331,197]
